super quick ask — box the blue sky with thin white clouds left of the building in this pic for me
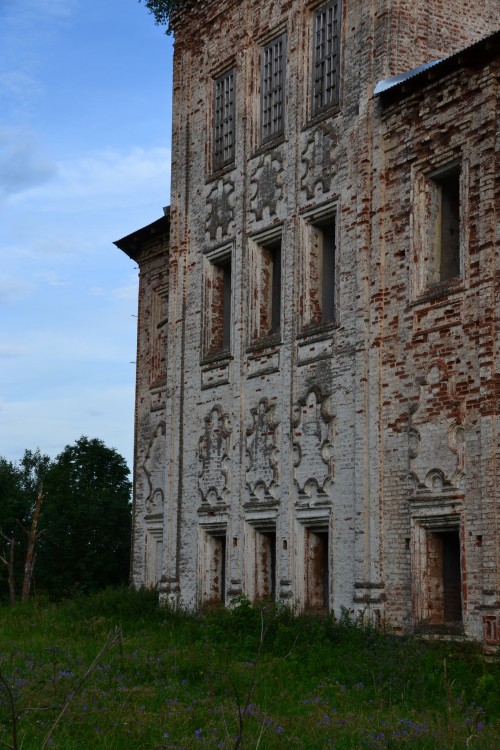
[0,0,172,467]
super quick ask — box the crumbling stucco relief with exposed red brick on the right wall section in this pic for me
[408,360,465,494]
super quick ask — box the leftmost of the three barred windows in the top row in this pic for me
[213,68,235,169]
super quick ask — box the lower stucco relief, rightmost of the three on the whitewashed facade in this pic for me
[292,387,334,502]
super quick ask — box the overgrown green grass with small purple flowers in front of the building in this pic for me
[0,590,500,750]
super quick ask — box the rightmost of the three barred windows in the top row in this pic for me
[312,0,340,114]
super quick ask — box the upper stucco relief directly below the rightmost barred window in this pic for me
[301,123,337,200]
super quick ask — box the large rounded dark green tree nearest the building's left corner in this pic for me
[35,437,131,596]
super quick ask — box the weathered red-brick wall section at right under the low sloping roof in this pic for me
[378,57,500,643]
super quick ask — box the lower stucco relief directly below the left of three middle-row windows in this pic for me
[198,405,231,505]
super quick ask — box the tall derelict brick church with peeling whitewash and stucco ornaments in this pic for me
[116,0,500,651]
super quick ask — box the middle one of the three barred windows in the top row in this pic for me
[261,34,286,143]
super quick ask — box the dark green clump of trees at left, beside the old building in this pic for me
[0,437,131,598]
